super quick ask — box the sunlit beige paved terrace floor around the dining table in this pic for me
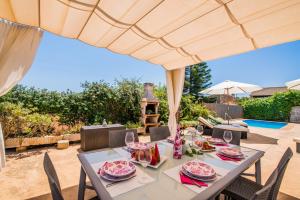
[0,124,300,200]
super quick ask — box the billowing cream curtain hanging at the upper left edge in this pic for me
[0,20,43,96]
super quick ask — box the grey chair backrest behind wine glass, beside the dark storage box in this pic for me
[108,129,139,148]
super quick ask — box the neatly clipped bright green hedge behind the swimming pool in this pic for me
[240,91,300,121]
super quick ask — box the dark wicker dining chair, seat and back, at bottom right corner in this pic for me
[222,148,293,200]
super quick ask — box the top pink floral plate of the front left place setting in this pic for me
[101,160,136,177]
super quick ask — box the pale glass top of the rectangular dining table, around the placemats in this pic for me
[78,141,264,200]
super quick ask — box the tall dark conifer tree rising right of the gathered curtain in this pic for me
[183,62,211,100]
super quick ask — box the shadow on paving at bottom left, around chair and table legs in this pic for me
[27,185,97,200]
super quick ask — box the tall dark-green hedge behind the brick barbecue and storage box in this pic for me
[0,79,209,131]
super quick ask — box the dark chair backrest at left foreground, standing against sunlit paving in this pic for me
[44,152,64,200]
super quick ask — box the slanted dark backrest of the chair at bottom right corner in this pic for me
[269,147,293,200]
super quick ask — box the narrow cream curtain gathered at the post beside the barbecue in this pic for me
[166,68,185,135]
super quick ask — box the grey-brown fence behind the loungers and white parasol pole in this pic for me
[204,103,243,119]
